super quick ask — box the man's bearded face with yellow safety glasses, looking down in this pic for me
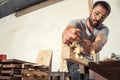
[89,5,107,27]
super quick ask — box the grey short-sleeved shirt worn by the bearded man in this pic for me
[69,18,109,45]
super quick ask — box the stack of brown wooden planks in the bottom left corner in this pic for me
[0,59,49,80]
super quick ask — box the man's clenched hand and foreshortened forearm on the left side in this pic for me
[62,26,80,44]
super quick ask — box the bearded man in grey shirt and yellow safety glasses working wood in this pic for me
[62,1,111,80]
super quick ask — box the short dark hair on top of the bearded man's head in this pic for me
[93,1,111,15]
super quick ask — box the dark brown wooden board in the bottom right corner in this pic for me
[89,61,120,80]
